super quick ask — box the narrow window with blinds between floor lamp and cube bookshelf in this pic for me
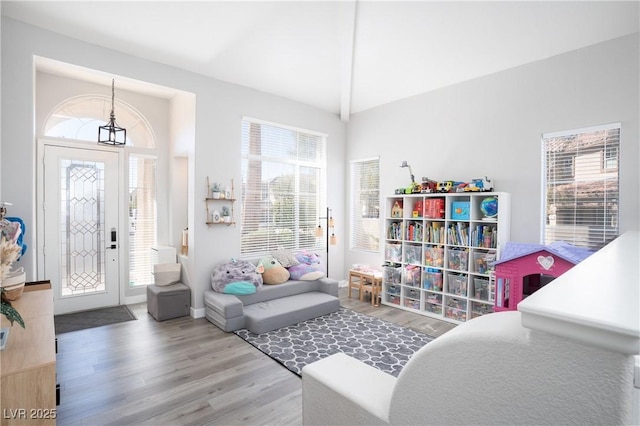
[350,158,380,252]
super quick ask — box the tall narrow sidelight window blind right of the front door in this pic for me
[129,154,157,287]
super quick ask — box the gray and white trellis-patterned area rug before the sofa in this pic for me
[235,308,434,377]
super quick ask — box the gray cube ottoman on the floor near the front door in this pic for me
[147,283,191,321]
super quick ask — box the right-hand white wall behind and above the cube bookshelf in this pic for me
[345,33,640,272]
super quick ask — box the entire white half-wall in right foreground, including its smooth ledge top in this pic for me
[302,231,640,425]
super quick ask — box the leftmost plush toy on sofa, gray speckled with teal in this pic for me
[211,259,262,295]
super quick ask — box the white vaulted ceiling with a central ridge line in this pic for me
[0,0,640,120]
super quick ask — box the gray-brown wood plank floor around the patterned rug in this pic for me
[57,288,454,425]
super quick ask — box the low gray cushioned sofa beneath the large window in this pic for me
[204,278,340,334]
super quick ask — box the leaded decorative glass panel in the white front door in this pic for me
[59,159,106,297]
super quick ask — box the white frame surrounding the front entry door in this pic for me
[36,138,128,312]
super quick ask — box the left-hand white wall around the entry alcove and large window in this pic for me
[0,17,345,309]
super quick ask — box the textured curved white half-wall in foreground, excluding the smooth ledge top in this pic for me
[302,312,634,425]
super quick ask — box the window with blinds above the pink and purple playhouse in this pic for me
[542,123,620,249]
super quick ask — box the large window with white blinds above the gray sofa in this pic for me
[240,118,327,257]
